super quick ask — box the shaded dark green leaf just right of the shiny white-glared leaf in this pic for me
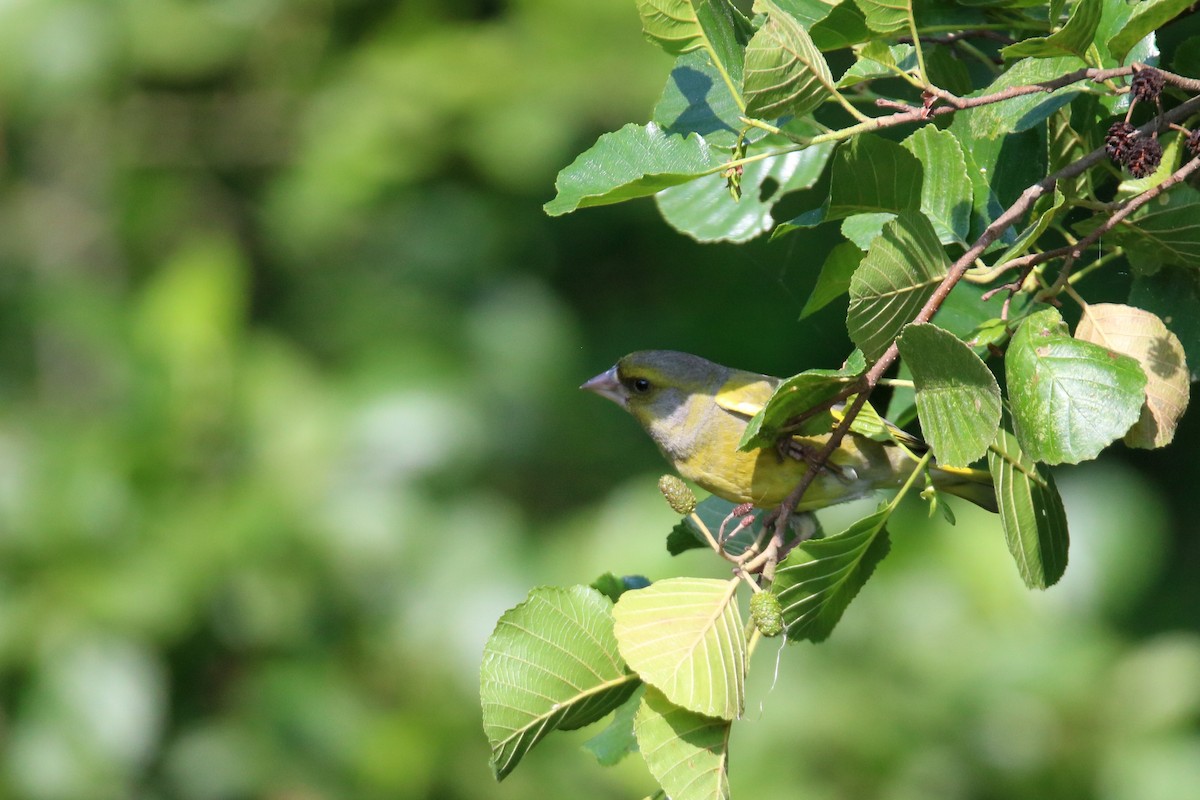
[826,134,924,219]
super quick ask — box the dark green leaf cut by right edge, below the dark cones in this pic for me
[1106,186,1200,267]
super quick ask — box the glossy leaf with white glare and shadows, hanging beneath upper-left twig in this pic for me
[654,137,833,242]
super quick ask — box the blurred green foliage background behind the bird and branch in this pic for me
[0,0,1200,800]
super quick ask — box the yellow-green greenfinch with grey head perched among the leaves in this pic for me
[581,350,996,511]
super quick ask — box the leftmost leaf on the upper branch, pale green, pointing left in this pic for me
[542,122,724,217]
